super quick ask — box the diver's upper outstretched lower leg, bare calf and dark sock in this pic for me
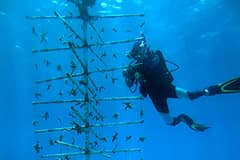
[176,87,206,100]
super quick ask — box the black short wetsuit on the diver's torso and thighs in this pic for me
[126,50,177,113]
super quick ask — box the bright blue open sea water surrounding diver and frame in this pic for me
[0,0,240,160]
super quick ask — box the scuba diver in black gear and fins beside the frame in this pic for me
[123,36,240,131]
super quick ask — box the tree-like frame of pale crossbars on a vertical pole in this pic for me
[26,0,144,160]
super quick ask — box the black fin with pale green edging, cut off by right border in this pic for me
[204,77,240,96]
